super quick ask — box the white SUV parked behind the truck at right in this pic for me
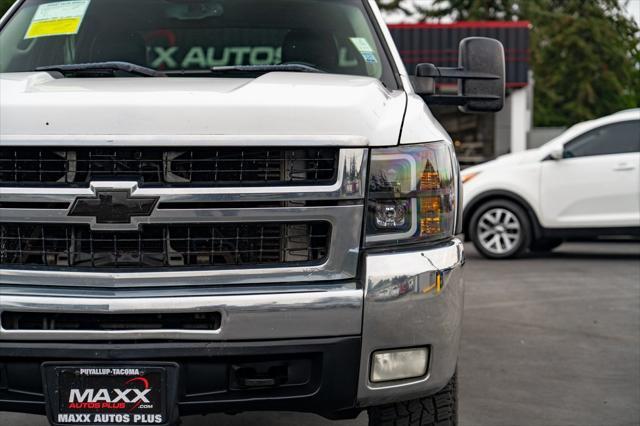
[462,109,640,259]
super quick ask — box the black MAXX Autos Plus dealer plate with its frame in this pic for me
[41,361,178,426]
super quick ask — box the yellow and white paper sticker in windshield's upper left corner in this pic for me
[24,0,91,39]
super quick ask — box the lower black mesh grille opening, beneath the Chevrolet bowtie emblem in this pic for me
[0,222,331,269]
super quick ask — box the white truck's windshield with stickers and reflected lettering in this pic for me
[0,0,395,86]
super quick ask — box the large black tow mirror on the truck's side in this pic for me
[414,37,505,112]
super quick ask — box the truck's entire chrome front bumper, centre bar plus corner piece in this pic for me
[0,240,464,407]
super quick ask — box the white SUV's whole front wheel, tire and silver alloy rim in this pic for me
[469,200,531,259]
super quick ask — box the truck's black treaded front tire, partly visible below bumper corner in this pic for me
[369,374,458,426]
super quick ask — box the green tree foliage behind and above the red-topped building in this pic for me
[376,0,640,126]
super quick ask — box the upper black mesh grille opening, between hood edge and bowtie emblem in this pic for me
[0,147,339,187]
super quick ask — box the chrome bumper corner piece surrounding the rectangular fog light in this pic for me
[358,239,464,407]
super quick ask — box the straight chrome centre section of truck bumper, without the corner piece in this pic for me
[0,283,363,341]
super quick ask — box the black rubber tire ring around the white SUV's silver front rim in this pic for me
[469,200,531,259]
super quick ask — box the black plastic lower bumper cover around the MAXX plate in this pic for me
[0,337,361,418]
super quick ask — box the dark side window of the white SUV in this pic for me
[564,120,640,158]
